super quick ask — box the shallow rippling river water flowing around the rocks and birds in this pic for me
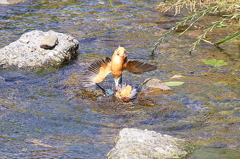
[0,0,240,159]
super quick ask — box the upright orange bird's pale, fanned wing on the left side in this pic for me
[81,57,111,87]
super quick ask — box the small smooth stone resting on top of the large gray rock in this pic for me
[40,35,58,49]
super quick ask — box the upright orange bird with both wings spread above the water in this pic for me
[81,46,157,93]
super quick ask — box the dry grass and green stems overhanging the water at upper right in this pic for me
[151,0,240,55]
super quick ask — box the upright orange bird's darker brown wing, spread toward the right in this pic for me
[123,60,157,73]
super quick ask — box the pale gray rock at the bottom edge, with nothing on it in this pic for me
[107,128,192,159]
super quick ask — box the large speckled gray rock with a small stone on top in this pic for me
[0,30,79,69]
